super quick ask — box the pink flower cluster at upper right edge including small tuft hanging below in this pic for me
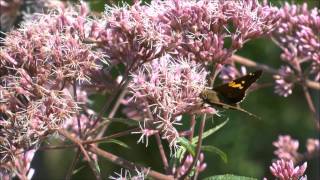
[272,3,320,97]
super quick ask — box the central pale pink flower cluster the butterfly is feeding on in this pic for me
[129,55,207,145]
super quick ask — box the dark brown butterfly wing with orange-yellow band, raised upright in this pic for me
[213,70,262,104]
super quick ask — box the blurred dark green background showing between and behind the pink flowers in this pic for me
[23,0,320,180]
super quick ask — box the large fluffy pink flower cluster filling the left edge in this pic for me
[0,1,103,176]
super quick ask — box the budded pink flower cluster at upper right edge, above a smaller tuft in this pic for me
[273,3,320,64]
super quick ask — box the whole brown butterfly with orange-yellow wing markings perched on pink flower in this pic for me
[200,70,262,118]
